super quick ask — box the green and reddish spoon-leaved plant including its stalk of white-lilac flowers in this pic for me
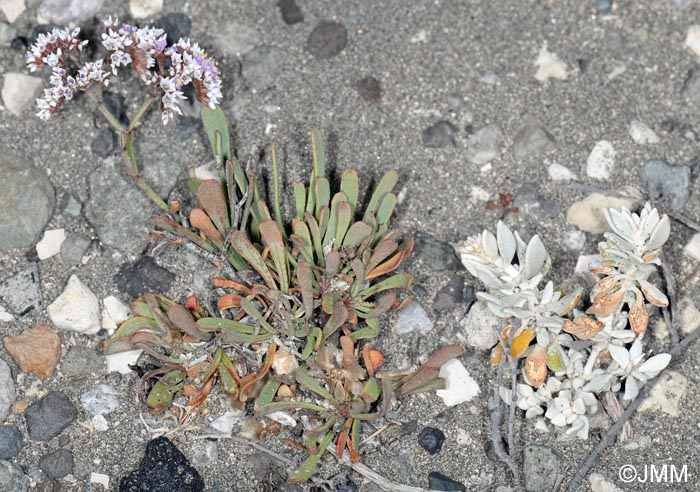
[27,18,462,481]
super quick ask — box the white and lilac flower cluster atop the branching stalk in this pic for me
[26,17,222,124]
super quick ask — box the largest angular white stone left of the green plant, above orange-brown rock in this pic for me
[48,275,100,335]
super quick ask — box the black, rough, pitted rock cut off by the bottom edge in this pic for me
[119,437,204,492]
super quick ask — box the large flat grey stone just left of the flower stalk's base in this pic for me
[85,158,156,254]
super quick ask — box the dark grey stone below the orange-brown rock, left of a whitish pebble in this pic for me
[24,391,78,441]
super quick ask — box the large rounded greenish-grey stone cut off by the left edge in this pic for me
[0,157,56,250]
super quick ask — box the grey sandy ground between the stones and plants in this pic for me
[0,0,700,491]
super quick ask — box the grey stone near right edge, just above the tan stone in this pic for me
[639,160,690,210]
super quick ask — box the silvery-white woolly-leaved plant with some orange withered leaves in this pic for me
[459,204,671,439]
